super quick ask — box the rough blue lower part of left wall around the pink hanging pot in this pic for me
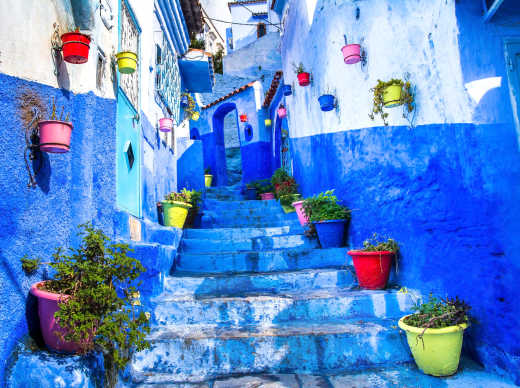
[0,74,116,382]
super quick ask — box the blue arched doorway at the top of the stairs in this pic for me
[212,103,242,186]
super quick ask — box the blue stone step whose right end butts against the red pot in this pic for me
[163,267,356,299]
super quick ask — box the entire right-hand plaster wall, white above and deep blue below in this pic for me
[280,0,520,383]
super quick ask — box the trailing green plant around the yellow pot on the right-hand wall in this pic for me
[368,78,415,127]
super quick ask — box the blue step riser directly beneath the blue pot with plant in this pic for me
[175,248,352,275]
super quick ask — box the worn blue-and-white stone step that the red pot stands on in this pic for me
[153,288,413,327]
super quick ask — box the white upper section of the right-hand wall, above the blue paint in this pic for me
[281,0,472,137]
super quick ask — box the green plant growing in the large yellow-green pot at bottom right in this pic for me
[404,293,471,330]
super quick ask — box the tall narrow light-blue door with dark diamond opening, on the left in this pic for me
[116,0,141,217]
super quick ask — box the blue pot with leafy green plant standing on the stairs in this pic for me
[303,190,350,248]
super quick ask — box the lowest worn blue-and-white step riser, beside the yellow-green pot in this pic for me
[132,328,411,383]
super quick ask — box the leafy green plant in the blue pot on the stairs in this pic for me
[303,190,350,222]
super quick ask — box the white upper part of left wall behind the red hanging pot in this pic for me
[0,0,118,98]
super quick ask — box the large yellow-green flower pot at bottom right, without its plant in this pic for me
[399,315,468,376]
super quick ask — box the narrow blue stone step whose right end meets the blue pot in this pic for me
[184,225,302,240]
